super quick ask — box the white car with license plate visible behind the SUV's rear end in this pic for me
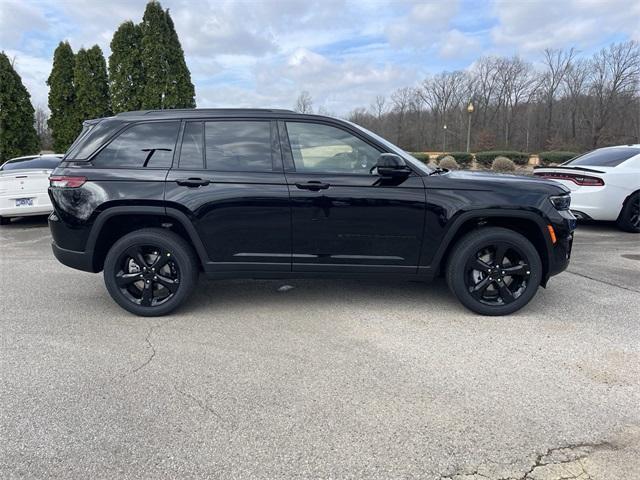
[0,155,62,225]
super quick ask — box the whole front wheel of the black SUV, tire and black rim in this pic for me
[446,227,542,315]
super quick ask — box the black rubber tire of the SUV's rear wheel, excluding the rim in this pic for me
[103,230,198,317]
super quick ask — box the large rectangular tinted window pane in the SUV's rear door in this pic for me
[205,121,272,172]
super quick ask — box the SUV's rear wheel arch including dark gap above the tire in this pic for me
[86,206,207,272]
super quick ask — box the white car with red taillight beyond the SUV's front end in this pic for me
[534,145,640,233]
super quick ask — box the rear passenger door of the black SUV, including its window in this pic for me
[165,118,291,272]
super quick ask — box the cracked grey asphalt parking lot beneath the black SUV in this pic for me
[0,219,640,480]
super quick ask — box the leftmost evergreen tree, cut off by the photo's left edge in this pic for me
[0,52,40,164]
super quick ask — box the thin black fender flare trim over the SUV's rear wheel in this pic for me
[86,206,209,270]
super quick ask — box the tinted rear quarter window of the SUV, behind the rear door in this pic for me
[94,122,180,168]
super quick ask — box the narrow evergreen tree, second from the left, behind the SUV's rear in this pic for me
[47,42,77,152]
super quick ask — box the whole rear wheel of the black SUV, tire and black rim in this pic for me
[104,228,199,317]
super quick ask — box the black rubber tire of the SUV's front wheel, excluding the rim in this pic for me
[447,228,542,315]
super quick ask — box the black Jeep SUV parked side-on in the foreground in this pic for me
[49,109,575,316]
